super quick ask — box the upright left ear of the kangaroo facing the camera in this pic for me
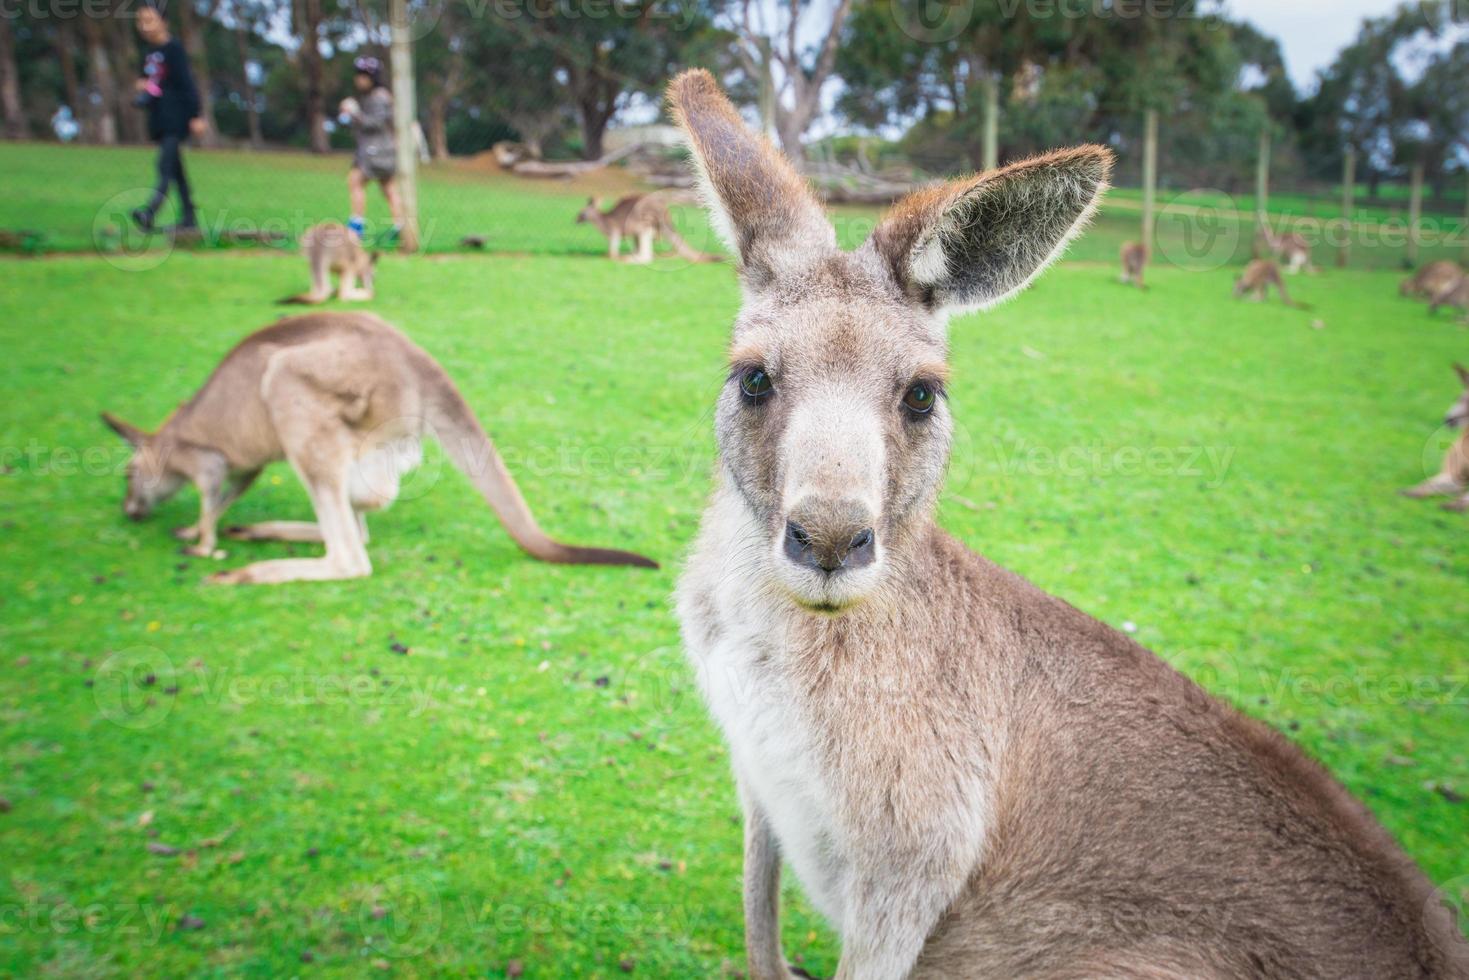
[668,69,836,285]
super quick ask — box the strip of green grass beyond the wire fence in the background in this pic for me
[0,143,1466,272]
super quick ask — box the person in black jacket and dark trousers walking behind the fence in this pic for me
[132,6,204,231]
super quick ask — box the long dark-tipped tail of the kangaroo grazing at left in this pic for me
[429,375,658,569]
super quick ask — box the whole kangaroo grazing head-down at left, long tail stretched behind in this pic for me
[103,313,658,583]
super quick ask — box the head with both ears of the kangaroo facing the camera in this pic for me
[668,71,1112,611]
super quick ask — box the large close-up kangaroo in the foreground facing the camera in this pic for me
[668,71,1469,980]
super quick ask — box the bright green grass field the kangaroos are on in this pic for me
[0,148,1469,977]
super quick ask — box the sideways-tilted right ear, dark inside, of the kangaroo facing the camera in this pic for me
[864,145,1112,313]
